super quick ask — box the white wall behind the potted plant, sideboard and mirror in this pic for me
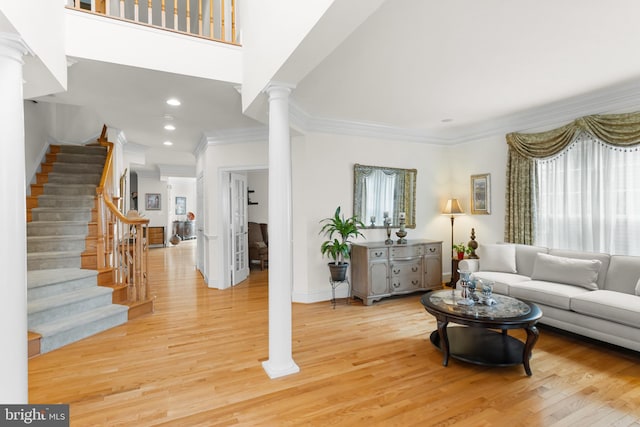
[292,133,451,302]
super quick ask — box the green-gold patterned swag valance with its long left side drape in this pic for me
[504,112,640,245]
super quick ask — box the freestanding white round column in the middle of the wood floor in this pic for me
[262,83,300,378]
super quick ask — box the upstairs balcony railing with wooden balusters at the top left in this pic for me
[67,0,239,45]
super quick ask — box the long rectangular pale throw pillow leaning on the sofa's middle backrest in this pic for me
[531,253,602,291]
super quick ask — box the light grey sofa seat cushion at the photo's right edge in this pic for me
[571,290,640,327]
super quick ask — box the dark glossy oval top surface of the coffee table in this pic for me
[425,290,531,319]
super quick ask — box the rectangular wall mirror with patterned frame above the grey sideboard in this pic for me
[353,163,418,228]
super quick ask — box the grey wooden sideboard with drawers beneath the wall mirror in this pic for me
[351,240,442,305]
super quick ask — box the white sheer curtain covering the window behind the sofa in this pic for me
[535,132,640,255]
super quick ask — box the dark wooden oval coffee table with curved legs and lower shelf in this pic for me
[420,290,542,376]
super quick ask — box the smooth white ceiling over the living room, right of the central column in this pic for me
[294,0,640,141]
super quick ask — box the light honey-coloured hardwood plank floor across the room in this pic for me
[29,241,640,426]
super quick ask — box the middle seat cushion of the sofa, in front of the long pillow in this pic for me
[509,280,592,310]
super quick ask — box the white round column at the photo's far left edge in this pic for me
[0,33,29,404]
